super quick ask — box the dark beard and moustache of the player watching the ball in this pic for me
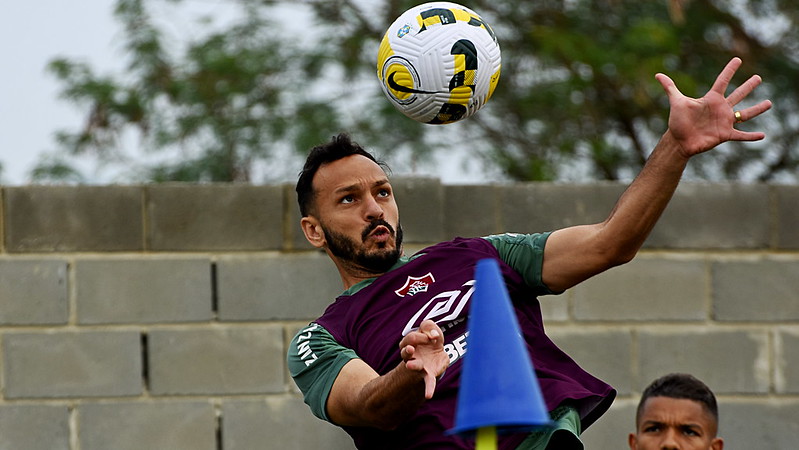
[322,219,402,274]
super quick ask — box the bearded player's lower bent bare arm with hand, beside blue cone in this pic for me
[327,320,449,430]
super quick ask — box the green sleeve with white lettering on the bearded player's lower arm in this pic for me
[287,323,358,422]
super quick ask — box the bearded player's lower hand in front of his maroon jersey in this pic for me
[400,320,449,400]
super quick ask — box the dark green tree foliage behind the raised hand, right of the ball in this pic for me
[304,0,799,181]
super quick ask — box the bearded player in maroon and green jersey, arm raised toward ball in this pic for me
[288,58,771,449]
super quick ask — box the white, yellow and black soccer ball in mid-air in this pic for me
[377,2,501,124]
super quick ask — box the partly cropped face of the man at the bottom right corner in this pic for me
[628,397,724,450]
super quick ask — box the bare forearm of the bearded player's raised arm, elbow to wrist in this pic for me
[602,131,688,263]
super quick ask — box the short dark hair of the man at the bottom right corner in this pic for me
[635,373,719,426]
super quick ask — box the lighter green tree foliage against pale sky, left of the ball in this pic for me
[41,0,346,181]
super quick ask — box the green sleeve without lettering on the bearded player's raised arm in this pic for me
[485,232,560,295]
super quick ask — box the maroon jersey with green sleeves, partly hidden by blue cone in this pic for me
[288,234,616,449]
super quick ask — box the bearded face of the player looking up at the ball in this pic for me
[313,155,402,273]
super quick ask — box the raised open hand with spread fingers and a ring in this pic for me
[655,57,771,158]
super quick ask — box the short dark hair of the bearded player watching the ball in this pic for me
[296,133,388,217]
